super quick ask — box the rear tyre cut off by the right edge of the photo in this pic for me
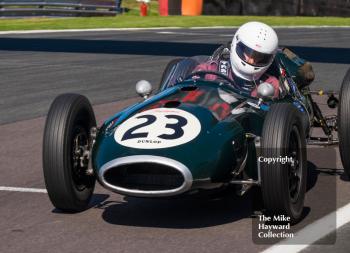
[338,69,350,178]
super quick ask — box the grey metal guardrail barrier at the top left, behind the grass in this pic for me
[0,0,118,16]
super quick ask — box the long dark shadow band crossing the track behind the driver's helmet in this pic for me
[0,38,350,64]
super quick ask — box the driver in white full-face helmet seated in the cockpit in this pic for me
[193,22,280,98]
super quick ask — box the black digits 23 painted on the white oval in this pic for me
[122,114,187,141]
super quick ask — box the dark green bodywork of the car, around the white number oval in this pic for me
[92,52,308,190]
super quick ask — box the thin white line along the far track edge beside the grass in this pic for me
[0,25,350,35]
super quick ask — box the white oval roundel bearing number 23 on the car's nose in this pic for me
[114,108,201,149]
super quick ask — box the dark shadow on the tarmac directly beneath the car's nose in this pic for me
[99,189,254,229]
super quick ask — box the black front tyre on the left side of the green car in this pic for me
[43,94,96,212]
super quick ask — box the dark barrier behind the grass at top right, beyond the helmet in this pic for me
[203,0,350,17]
